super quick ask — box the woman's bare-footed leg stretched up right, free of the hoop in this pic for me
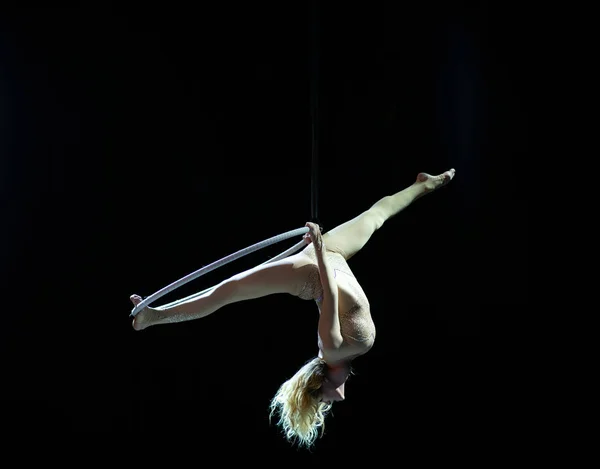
[323,169,455,260]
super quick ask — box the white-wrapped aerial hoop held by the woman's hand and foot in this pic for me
[130,227,308,316]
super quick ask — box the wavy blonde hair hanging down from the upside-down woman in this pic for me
[269,357,331,448]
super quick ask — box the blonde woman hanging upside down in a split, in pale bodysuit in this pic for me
[130,169,455,447]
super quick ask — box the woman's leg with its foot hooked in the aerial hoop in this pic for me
[130,253,310,331]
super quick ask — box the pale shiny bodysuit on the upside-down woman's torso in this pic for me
[298,244,375,355]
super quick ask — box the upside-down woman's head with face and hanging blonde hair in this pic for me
[270,357,351,448]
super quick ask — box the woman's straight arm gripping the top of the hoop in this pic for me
[306,223,343,350]
